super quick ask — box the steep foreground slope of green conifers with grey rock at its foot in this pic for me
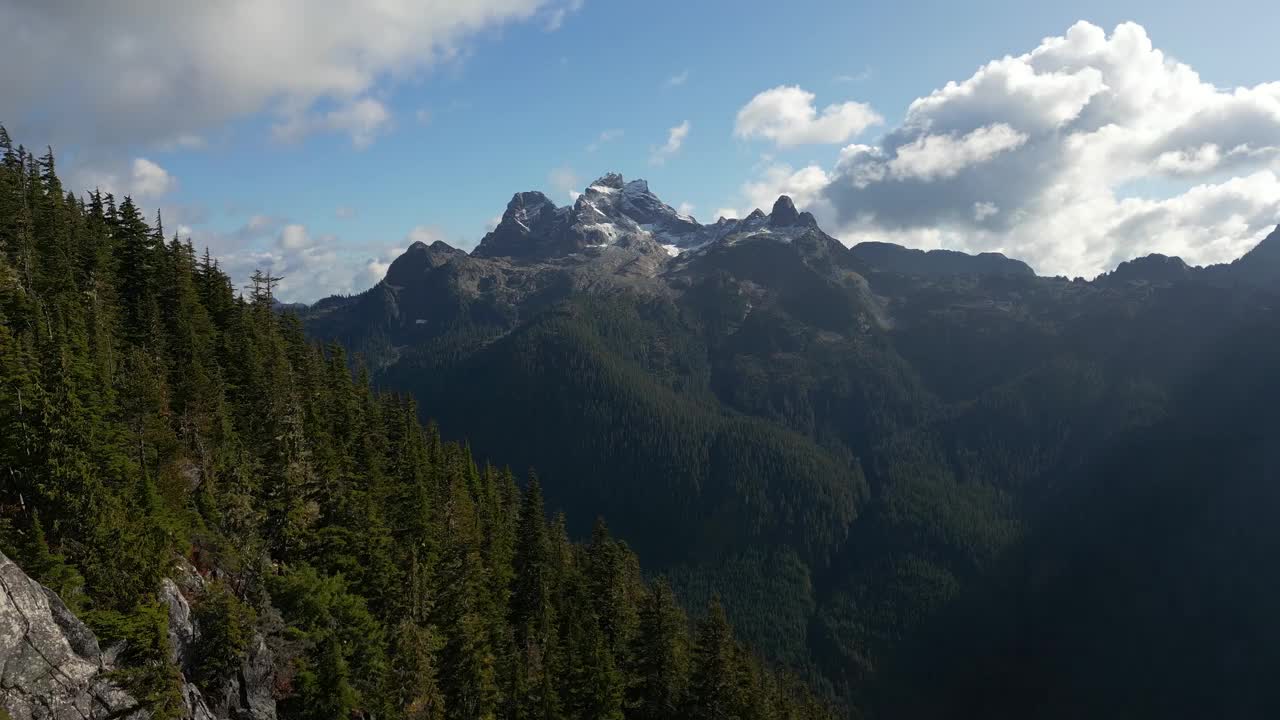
[0,128,828,720]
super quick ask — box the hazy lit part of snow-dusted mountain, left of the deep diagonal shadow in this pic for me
[306,170,1280,716]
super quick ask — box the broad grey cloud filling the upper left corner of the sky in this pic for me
[0,0,570,146]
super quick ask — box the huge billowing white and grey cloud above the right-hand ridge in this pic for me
[739,22,1280,277]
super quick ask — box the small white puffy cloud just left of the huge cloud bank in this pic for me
[733,86,884,147]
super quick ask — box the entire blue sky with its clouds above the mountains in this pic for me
[0,0,1280,301]
